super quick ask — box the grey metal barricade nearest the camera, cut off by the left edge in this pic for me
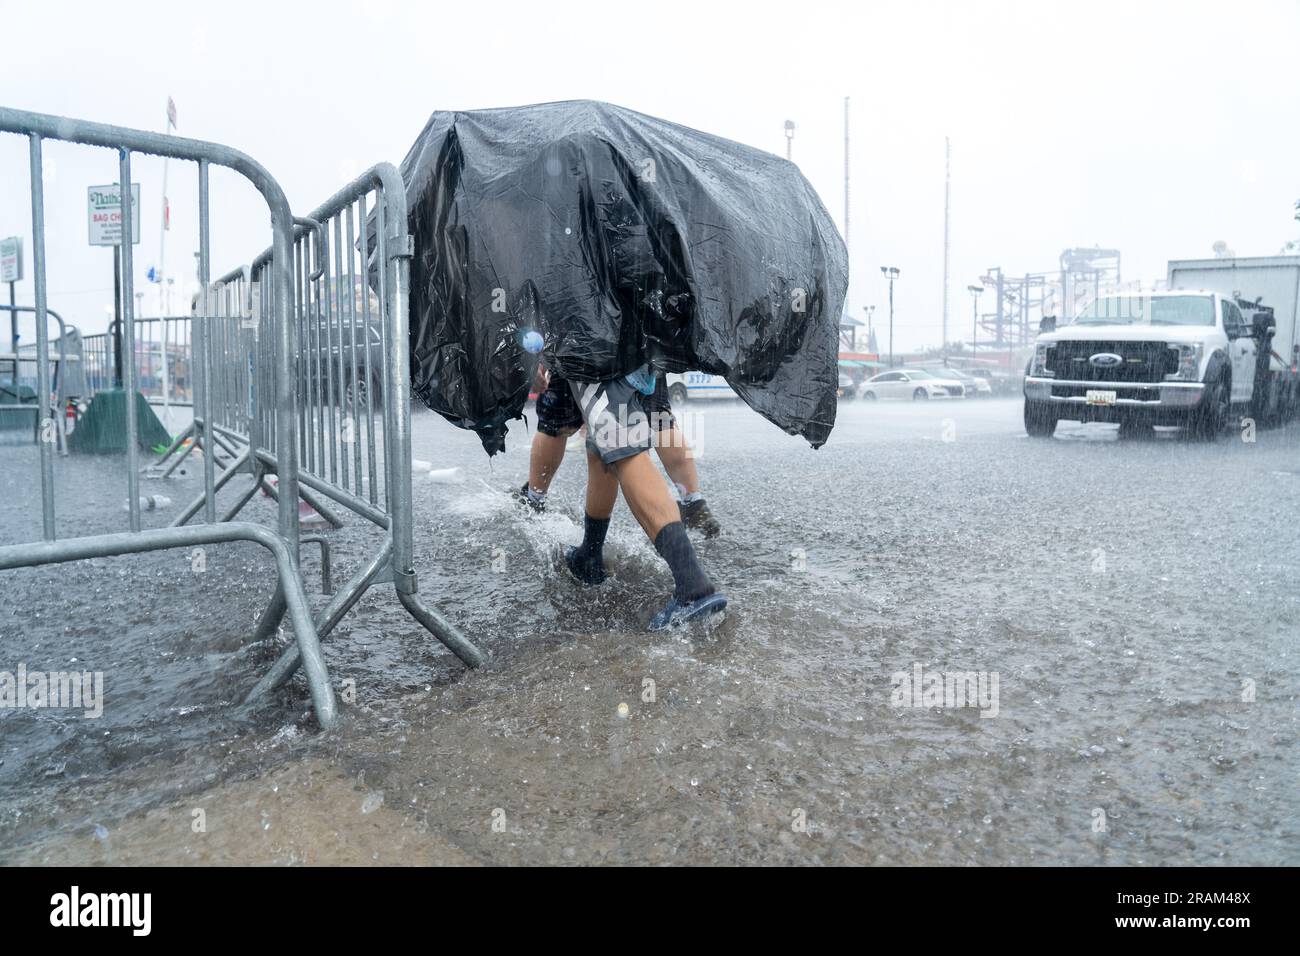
[0,108,337,727]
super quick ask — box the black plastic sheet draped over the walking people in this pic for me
[402,100,848,454]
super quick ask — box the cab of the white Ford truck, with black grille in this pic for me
[1024,290,1271,440]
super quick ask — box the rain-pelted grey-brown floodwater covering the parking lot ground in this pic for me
[0,399,1300,865]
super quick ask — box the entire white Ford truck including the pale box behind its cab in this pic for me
[1024,256,1300,440]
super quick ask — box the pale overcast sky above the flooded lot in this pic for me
[0,0,1300,349]
